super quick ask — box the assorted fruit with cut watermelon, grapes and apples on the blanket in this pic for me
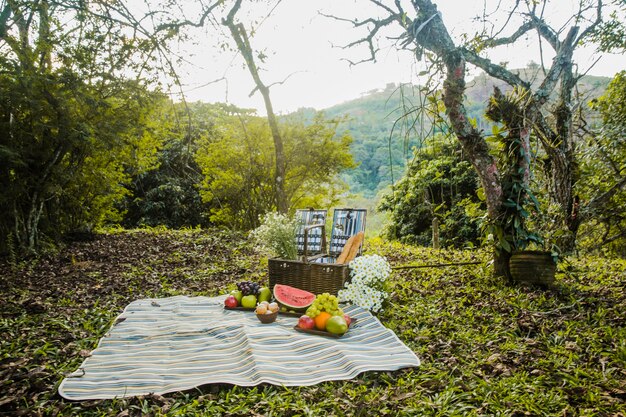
[224,281,352,335]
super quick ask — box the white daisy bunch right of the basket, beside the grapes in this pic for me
[339,255,391,312]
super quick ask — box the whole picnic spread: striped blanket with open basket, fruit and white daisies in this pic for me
[59,209,420,400]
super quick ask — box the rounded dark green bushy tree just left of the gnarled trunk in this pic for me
[379,136,484,247]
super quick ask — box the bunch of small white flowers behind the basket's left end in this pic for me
[250,212,299,259]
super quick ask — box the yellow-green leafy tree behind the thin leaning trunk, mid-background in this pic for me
[196,108,353,229]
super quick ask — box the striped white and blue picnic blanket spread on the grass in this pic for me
[59,296,420,400]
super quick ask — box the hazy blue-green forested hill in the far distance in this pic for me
[294,69,610,197]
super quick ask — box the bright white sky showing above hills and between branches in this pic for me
[167,0,626,115]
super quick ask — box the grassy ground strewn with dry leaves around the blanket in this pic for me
[0,230,626,417]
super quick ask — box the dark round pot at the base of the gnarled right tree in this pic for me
[509,250,556,287]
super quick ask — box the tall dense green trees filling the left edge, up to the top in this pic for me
[0,2,165,254]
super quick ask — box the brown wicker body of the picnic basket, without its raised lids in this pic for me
[268,258,350,295]
